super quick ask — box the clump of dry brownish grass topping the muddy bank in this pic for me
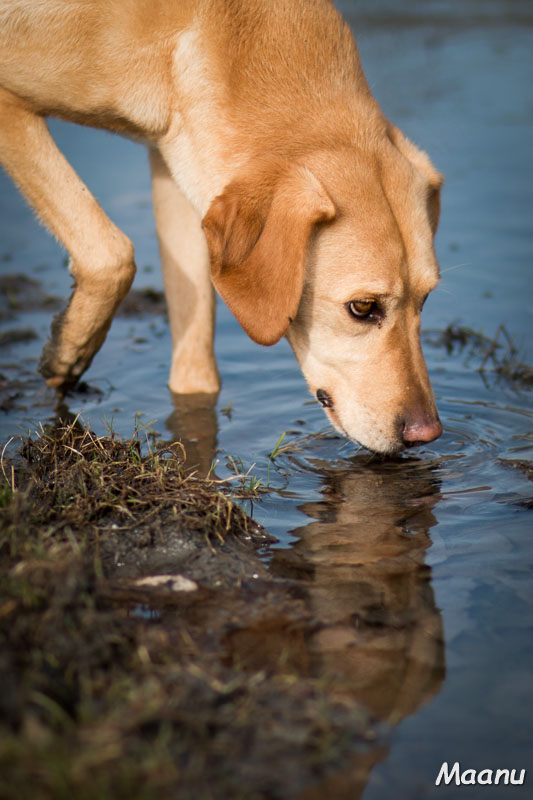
[0,423,260,548]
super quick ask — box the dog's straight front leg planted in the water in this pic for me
[150,149,220,394]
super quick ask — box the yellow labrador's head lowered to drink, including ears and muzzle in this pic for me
[203,131,442,453]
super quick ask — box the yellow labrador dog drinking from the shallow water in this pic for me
[0,0,442,453]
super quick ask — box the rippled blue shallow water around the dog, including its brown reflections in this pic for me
[0,0,533,800]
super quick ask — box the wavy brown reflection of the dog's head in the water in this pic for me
[272,461,444,722]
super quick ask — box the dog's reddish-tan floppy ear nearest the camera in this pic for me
[202,166,335,345]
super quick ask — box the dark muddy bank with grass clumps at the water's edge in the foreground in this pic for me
[0,423,385,800]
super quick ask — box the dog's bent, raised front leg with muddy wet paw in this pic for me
[0,89,135,388]
